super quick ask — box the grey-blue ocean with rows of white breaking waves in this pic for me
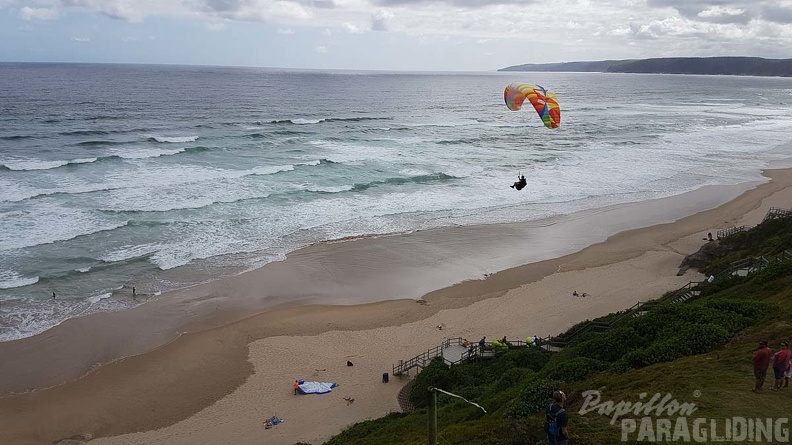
[0,63,792,341]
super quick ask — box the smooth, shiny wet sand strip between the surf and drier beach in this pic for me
[0,177,760,395]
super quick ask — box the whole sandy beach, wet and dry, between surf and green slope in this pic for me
[0,169,792,445]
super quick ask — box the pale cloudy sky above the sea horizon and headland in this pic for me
[0,0,792,71]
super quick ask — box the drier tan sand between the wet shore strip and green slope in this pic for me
[0,170,792,445]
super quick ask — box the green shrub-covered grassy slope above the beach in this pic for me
[304,218,792,445]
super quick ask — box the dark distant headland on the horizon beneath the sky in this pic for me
[498,57,792,77]
